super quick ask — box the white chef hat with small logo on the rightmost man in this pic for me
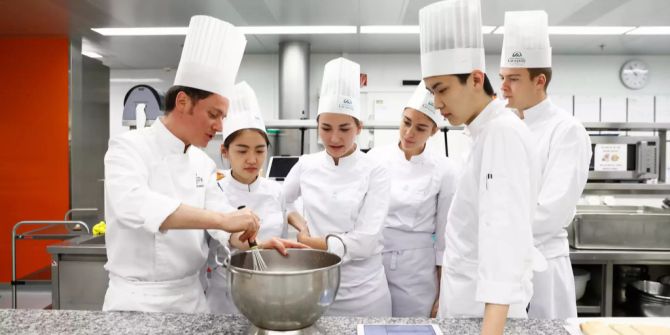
[500,10,551,68]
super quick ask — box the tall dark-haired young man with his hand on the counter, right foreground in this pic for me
[419,0,546,334]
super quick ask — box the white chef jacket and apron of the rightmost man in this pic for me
[523,98,591,319]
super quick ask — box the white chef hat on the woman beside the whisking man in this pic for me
[223,81,266,142]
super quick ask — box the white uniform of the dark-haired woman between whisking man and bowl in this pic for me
[206,170,287,314]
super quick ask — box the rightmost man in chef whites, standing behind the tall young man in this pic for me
[500,11,591,319]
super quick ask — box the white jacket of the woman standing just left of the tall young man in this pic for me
[368,143,457,266]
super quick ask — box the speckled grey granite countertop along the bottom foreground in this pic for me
[0,309,568,335]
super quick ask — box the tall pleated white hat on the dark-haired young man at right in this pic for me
[419,0,485,78]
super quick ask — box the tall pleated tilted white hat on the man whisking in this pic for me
[174,15,247,97]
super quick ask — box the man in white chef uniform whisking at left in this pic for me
[103,16,259,313]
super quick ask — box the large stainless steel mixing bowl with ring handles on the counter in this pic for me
[223,236,346,331]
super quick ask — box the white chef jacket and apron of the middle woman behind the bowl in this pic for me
[282,150,390,316]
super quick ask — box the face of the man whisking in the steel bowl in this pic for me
[184,94,229,148]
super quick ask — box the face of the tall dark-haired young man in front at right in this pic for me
[424,75,477,126]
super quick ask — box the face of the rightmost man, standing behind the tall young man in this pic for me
[500,67,544,111]
